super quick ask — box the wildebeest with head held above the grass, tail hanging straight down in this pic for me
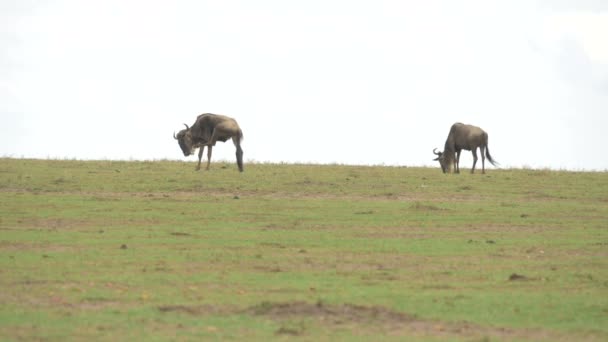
[173,113,243,172]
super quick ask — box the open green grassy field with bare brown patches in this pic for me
[0,159,608,341]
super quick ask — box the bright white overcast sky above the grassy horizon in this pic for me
[0,0,608,170]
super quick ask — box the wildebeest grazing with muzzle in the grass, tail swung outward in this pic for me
[433,122,498,173]
